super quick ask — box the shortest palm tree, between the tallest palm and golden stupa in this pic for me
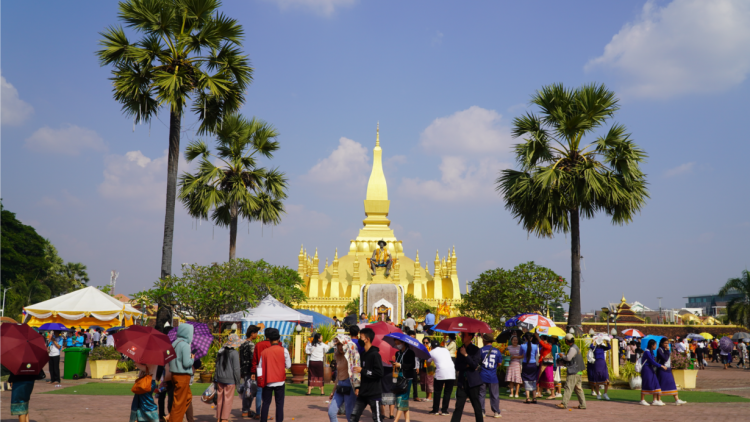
[180,114,287,260]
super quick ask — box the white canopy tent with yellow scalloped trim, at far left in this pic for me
[24,286,142,329]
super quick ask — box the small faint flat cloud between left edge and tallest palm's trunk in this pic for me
[25,125,107,155]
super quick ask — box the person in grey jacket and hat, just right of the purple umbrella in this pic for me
[214,334,242,422]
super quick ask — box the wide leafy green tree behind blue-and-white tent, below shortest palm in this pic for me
[133,259,307,323]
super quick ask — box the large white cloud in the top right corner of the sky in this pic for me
[585,0,750,98]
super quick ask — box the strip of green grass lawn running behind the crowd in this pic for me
[43,382,750,404]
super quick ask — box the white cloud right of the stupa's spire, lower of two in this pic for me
[399,156,508,202]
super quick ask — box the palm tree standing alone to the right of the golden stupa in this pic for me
[496,84,649,327]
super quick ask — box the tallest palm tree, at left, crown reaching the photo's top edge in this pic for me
[96,0,253,328]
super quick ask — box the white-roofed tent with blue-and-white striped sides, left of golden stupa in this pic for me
[219,295,313,336]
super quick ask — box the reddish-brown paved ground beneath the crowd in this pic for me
[0,367,750,422]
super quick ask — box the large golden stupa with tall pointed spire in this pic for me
[296,123,461,323]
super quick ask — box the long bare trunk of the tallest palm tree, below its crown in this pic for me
[156,110,182,330]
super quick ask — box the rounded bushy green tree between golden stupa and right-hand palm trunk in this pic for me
[458,261,570,328]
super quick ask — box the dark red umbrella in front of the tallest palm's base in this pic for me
[112,325,176,365]
